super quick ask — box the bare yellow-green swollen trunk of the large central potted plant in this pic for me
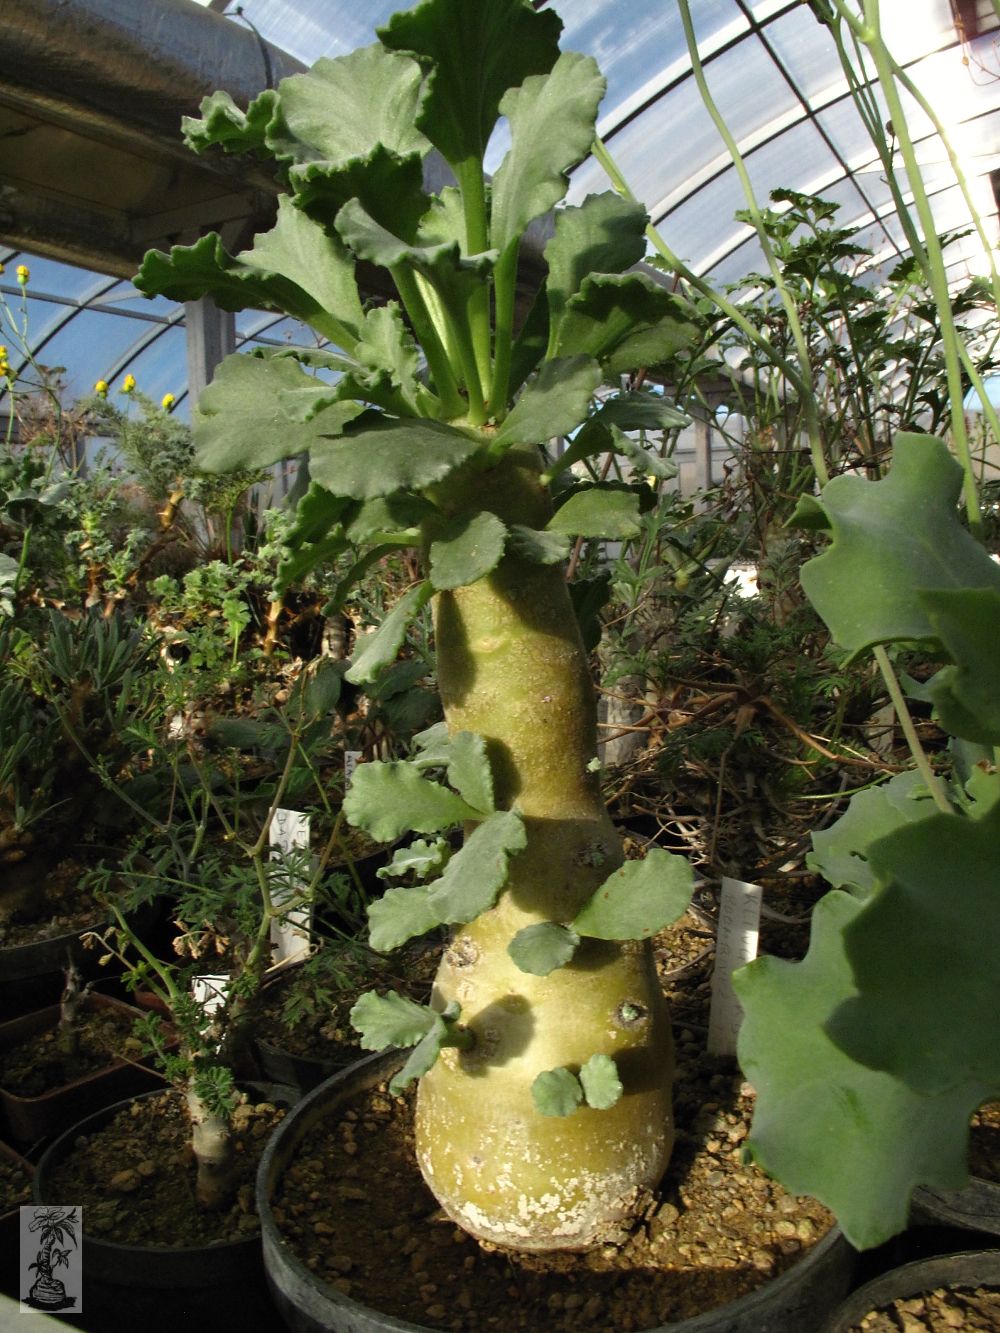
[416,456,673,1249]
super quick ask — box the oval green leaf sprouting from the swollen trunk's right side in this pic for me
[572,848,695,940]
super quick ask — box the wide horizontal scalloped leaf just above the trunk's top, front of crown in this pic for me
[312,412,483,500]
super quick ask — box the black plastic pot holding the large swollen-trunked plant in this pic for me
[257,1052,857,1333]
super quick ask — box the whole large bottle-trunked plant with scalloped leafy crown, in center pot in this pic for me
[139,0,697,1249]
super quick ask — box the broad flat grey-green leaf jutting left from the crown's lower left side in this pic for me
[195,353,361,480]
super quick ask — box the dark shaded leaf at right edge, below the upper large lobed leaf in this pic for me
[920,588,1000,745]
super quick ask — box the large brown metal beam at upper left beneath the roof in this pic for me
[0,0,304,277]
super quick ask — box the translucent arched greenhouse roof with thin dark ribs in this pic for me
[0,0,1000,413]
